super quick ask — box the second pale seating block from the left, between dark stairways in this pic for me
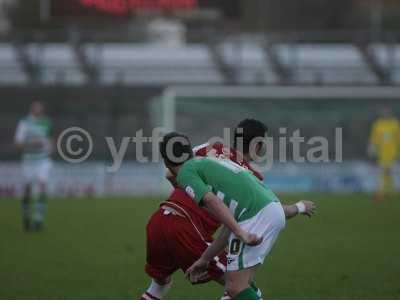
[26,43,86,84]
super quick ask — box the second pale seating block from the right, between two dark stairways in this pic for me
[274,44,377,84]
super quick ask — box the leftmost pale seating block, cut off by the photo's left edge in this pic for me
[0,43,28,84]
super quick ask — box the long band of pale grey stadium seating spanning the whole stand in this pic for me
[0,37,400,86]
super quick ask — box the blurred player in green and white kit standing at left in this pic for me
[15,101,52,231]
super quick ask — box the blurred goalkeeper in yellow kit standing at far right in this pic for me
[368,107,400,201]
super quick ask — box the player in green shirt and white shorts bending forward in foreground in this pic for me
[160,133,315,300]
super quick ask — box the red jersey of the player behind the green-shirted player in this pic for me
[163,143,264,235]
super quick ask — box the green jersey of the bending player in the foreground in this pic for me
[177,157,279,222]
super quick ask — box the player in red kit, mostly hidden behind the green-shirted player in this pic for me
[140,119,313,300]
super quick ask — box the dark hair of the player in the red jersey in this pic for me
[233,119,268,154]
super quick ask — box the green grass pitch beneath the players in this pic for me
[0,195,400,300]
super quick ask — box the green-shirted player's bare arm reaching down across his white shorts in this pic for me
[203,192,262,246]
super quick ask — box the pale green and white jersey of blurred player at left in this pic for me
[15,116,52,162]
